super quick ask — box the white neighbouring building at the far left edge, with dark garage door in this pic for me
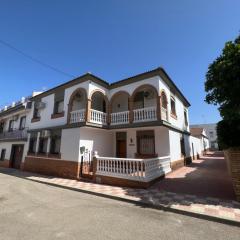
[0,96,32,168]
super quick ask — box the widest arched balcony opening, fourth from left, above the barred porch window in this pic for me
[131,84,159,122]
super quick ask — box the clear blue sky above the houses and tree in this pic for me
[0,0,240,123]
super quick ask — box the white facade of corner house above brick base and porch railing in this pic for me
[0,69,202,180]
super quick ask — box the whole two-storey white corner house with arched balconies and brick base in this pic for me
[0,68,206,186]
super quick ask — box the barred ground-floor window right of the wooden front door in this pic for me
[137,130,155,155]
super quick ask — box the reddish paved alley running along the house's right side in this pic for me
[153,152,235,200]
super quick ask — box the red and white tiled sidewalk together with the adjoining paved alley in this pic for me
[0,155,240,224]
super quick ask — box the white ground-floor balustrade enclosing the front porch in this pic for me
[95,156,171,182]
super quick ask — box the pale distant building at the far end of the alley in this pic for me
[190,123,218,150]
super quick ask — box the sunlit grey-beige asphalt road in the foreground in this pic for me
[0,171,240,240]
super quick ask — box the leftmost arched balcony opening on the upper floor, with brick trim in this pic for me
[68,88,87,124]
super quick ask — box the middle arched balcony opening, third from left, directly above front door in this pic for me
[110,91,130,125]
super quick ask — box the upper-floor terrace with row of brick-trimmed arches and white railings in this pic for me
[68,85,168,126]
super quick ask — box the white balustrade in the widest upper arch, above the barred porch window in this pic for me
[133,107,157,122]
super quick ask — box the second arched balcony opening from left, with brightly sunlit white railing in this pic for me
[90,91,108,125]
